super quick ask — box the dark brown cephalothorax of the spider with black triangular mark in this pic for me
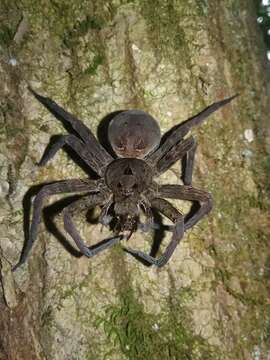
[105,158,152,215]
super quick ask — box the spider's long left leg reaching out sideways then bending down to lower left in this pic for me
[13,179,100,271]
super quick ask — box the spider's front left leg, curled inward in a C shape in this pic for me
[64,194,124,257]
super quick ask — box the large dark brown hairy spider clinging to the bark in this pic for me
[13,88,237,270]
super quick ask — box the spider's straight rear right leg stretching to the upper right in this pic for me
[146,95,238,166]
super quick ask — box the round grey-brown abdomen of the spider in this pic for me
[108,110,161,159]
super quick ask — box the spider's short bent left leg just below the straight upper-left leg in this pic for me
[38,134,102,175]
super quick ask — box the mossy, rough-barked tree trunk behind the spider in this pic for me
[0,0,270,360]
